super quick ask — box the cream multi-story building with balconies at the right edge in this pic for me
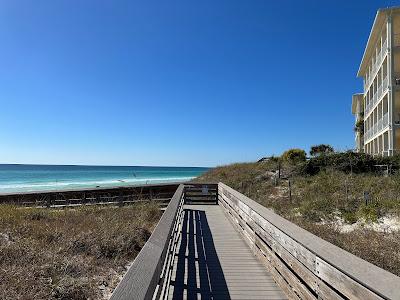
[352,6,400,155]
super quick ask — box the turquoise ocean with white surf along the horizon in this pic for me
[0,164,208,194]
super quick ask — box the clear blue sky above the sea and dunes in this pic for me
[0,0,396,166]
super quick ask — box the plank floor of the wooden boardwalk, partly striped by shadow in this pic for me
[169,205,287,299]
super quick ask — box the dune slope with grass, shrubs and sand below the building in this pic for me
[196,145,400,275]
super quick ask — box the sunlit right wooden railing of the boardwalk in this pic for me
[219,183,400,299]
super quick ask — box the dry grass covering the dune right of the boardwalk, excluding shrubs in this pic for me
[195,161,400,276]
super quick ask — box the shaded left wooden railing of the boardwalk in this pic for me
[110,184,184,300]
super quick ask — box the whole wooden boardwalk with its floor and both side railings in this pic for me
[111,183,400,300]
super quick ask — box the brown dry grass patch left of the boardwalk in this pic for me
[0,203,161,299]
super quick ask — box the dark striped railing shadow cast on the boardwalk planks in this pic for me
[173,209,230,299]
